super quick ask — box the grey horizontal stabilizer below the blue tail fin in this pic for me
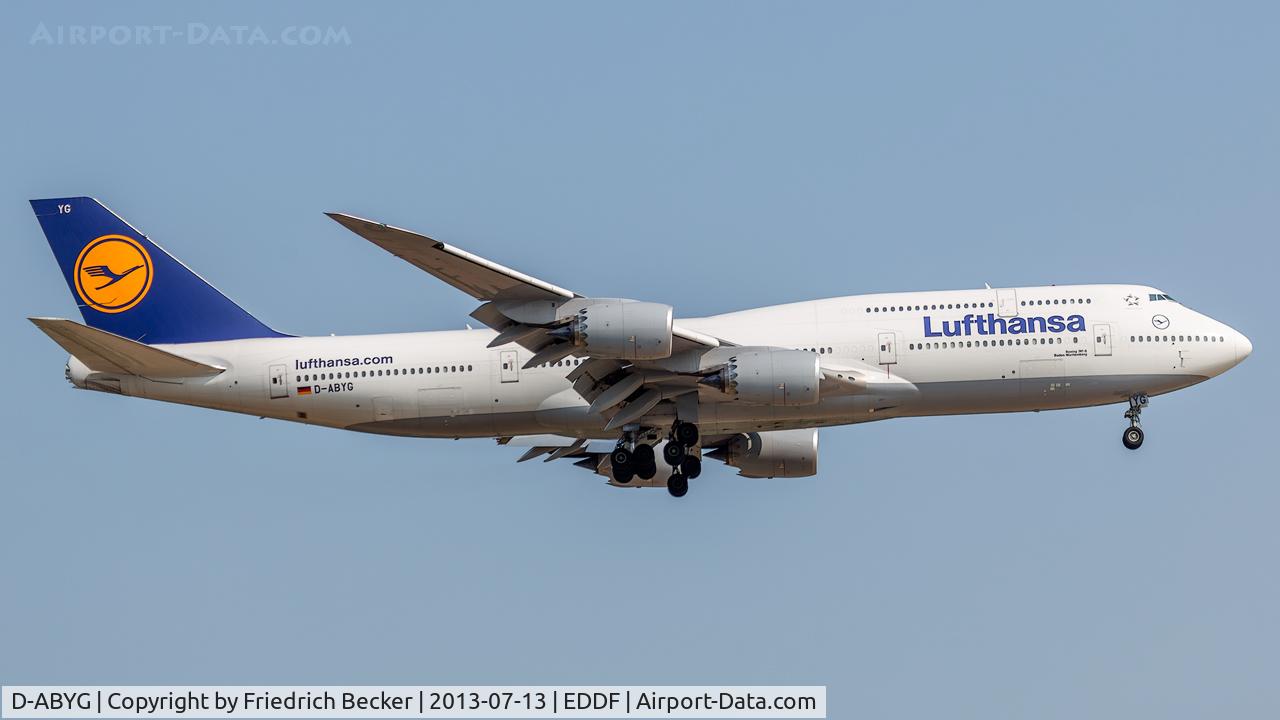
[28,318,224,378]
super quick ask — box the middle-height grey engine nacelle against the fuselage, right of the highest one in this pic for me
[701,347,822,406]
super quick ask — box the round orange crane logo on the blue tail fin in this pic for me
[74,234,154,313]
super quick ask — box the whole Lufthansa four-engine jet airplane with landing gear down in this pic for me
[31,197,1253,497]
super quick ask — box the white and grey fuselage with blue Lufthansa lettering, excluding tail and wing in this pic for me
[69,284,1252,438]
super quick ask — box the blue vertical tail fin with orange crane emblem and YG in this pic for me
[31,197,283,345]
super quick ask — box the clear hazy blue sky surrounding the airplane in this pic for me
[0,1,1280,719]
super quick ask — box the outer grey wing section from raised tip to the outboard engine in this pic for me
[325,213,577,300]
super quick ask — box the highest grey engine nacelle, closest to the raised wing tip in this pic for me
[565,300,672,360]
